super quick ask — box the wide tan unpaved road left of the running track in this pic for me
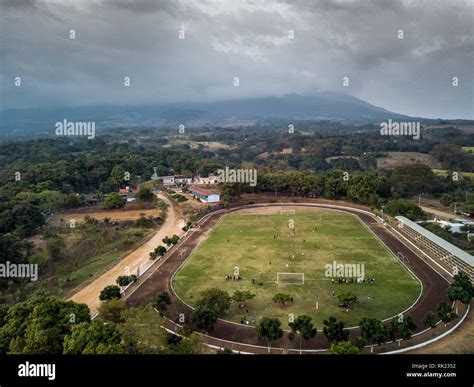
[70,194,183,315]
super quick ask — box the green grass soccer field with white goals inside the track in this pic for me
[173,208,421,329]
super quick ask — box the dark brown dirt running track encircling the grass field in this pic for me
[126,200,448,353]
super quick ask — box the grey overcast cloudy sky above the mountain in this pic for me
[0,0,474,118]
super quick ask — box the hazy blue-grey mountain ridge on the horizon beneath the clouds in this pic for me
[0,93,413,137]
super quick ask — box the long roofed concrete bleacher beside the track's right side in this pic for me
[396,216,474,281]
